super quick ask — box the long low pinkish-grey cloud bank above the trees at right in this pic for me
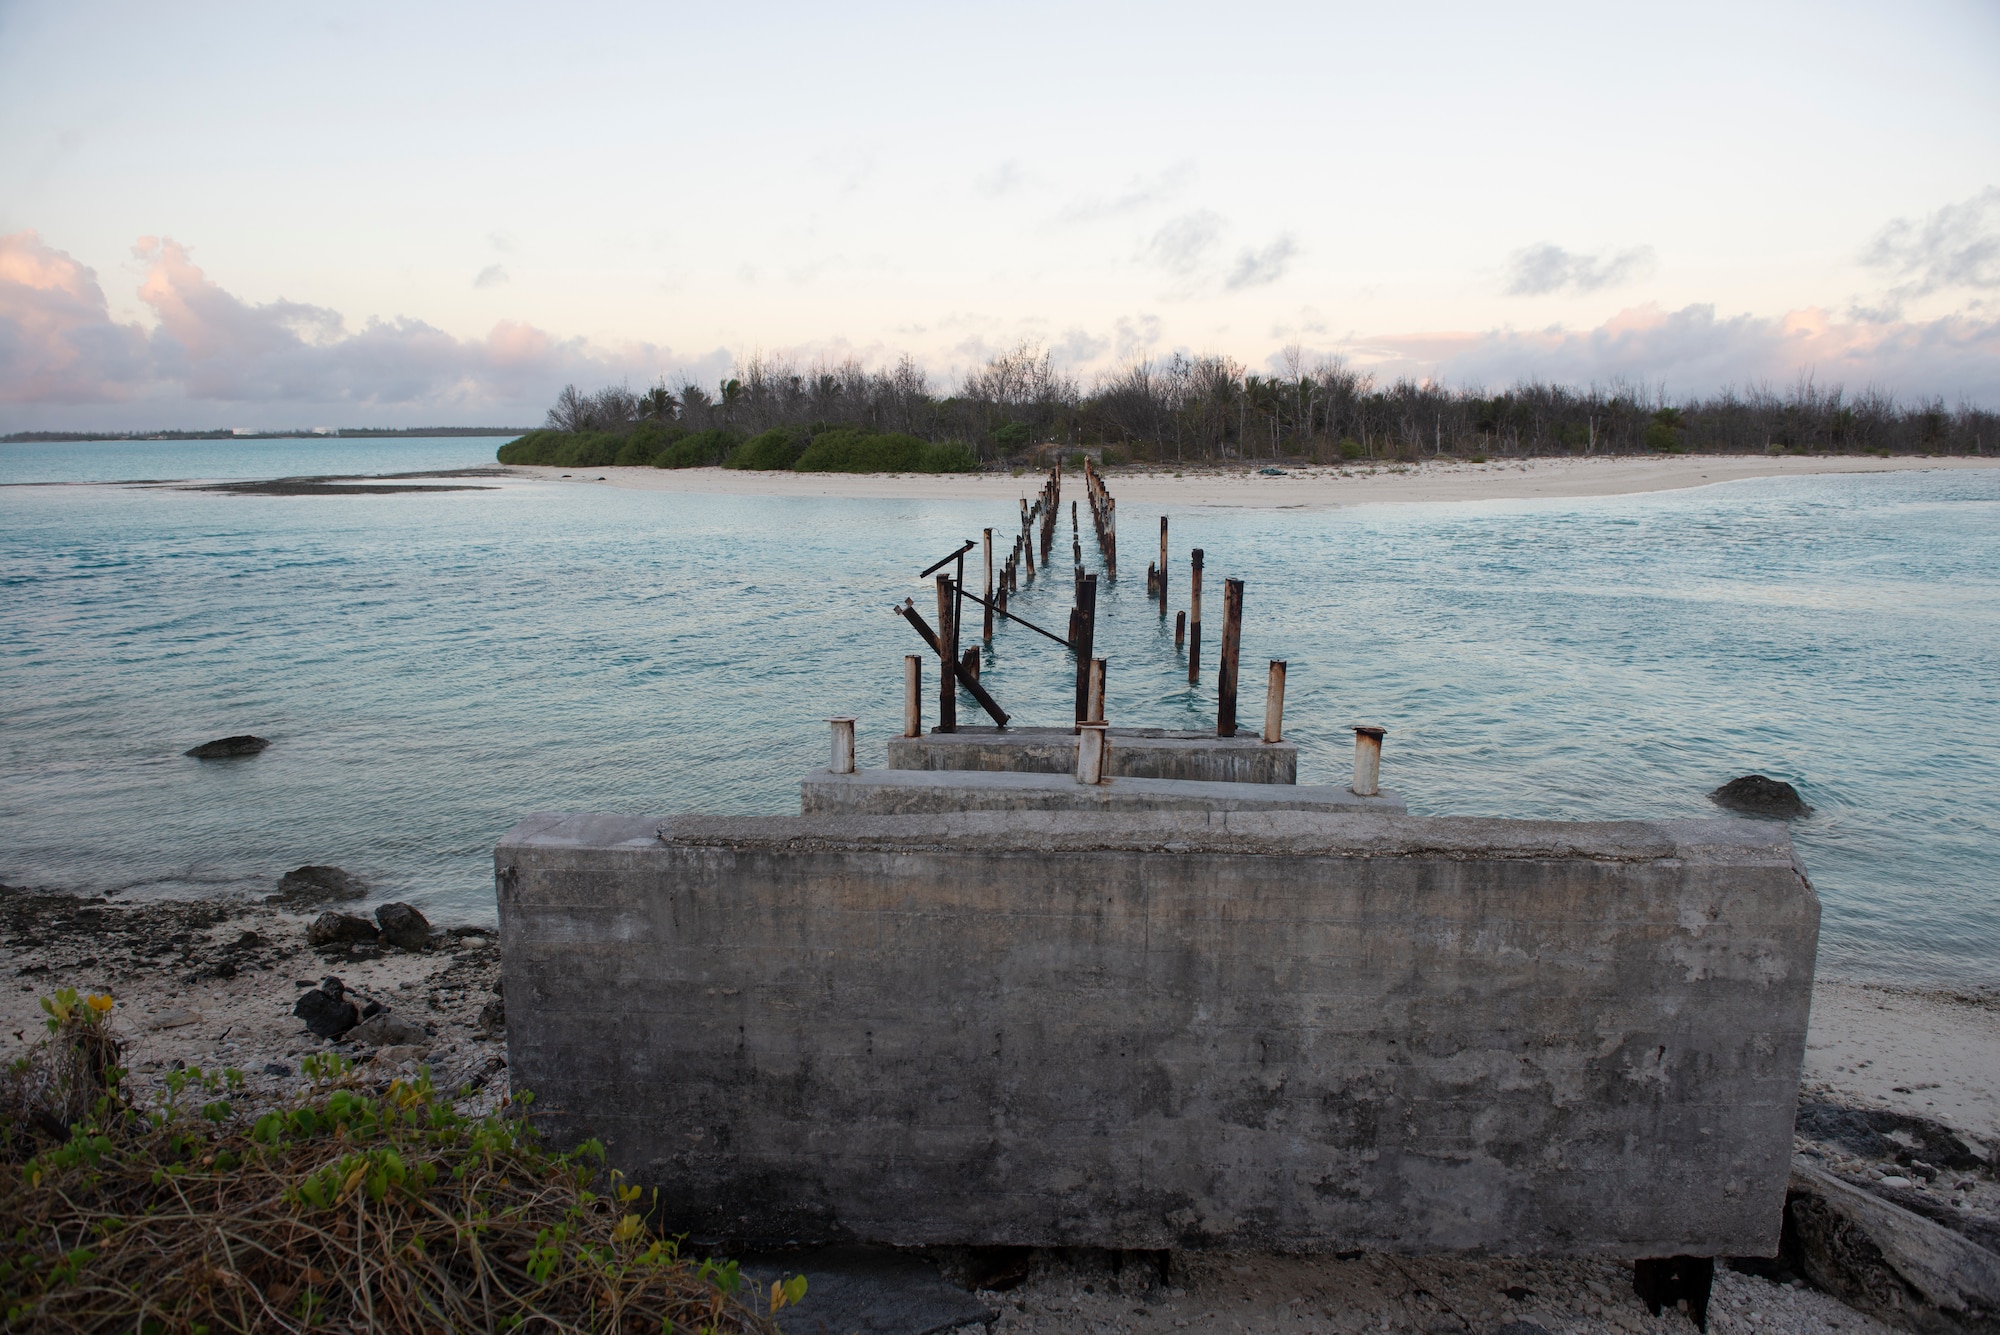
[1342,304,2000,404]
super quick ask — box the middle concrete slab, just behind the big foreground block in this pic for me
[798,769,1404,815]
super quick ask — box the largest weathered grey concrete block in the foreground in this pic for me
[496,811,1818,1257]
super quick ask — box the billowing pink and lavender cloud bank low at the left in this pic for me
[0,232,728,422]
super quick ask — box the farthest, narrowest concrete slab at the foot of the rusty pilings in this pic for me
[888,727,1298,783]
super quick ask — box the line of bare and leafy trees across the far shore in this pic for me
[524,344,2000,464]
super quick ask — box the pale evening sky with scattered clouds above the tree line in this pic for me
[0,0,2000,432]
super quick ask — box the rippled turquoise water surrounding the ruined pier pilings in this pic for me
[0,440,2000,983]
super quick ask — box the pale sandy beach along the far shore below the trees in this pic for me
[504,454,2000,510]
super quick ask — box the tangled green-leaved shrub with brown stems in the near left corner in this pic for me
[0,989,806,1335]
